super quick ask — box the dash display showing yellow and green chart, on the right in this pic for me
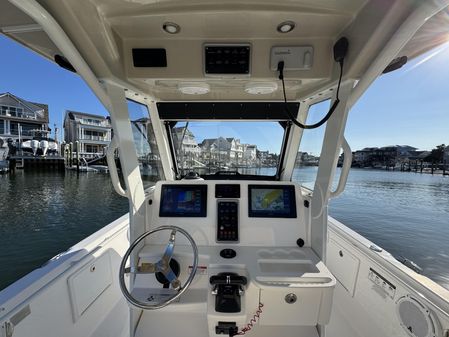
[248,185,296,218]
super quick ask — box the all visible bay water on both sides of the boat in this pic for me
[0,167,449,289]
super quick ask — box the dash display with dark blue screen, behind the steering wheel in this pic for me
[159,185,207,217]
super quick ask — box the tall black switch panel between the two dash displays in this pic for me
[217,200,239,242]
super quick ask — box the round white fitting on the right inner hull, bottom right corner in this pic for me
[396,295,441,337]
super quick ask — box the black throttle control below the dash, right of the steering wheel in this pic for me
[209,273,247,313]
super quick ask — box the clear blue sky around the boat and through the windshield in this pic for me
[0,35,449,155]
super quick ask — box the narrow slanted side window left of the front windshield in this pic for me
[128,100,165,188]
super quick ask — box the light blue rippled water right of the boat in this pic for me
[329,169,449,289]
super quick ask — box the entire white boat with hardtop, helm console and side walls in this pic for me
[0,0,449,337]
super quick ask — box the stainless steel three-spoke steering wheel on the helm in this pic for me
[119,226,198,310]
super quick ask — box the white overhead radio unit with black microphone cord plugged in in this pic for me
[270,46,313,71]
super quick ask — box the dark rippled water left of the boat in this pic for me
[0,170,128,289]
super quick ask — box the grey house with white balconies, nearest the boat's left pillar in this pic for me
[64,110,111,158]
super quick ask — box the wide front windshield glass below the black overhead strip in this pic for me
[171,121,284,176]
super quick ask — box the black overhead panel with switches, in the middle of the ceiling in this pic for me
[204,44,251,75]
